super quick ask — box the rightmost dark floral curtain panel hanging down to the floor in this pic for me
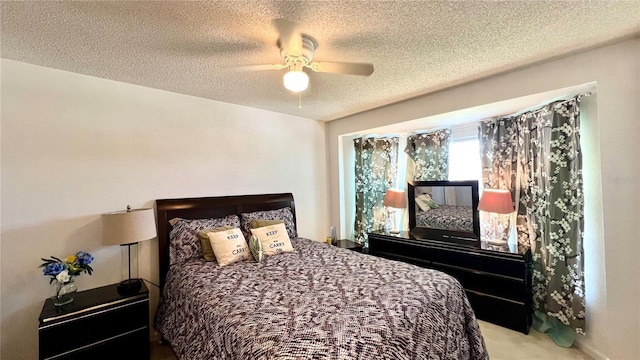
[518,98,585,333]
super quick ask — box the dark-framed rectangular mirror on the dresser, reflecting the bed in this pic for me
[407,180,480,247]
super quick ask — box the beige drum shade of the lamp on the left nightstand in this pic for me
[102,209,157,245]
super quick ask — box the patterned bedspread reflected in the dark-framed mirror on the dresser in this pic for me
[416,205,473,232]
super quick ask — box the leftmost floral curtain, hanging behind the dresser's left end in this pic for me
[353,137,398,246]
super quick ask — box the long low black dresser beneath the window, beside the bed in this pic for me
[369,232,532,334]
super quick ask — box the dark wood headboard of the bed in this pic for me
[156,193,297,289]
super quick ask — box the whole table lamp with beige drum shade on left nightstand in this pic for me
[102,206,157,295]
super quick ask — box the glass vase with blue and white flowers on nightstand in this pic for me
[40,251,93,306]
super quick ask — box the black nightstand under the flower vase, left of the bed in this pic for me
[38,283,149,360]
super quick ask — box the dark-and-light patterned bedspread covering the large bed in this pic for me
[155,238,488,360]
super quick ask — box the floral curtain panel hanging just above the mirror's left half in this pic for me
[404,129,451,181]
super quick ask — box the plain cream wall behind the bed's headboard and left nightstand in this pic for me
[0,59,329,360]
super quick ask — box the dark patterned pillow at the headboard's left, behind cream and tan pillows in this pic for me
[169,214,240,265]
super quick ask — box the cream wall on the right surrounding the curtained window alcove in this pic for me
[326,39,640,359]
